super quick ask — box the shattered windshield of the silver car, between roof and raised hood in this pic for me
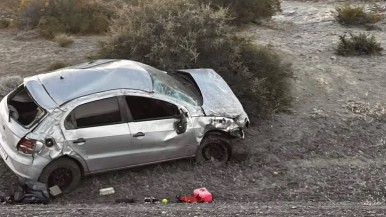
[144,66,201,106]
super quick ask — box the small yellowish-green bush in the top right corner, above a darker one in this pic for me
[334,4,381,25]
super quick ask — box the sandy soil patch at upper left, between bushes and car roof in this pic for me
[0,29,103,77]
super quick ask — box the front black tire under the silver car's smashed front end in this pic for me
[196,135,232,166]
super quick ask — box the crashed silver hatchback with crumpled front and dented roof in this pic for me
[0,60,249,192]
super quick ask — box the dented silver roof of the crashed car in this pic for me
[24,60,154,108]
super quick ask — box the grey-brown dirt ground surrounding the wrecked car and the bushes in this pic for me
[0,1,386,216]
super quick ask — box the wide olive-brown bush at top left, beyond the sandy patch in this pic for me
[18,0,112,37]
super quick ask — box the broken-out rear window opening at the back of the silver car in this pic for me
[8,85,45,128]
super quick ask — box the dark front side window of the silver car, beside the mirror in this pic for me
[126,96,179,121]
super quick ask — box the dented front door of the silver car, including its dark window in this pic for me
[125,96,196,164]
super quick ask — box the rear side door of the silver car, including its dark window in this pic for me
[63,97,131,172]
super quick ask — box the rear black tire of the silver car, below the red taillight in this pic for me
[39,158,82,193]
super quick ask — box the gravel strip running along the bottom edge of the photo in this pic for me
[0,202,386,217]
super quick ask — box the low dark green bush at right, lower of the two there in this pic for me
[336,33,383,56]
